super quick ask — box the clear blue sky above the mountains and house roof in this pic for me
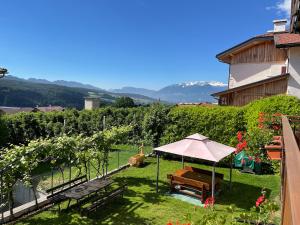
[0,0,290,89]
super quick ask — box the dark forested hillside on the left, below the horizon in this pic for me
[0,76,155,109]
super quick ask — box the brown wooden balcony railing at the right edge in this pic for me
[281,116,300,225]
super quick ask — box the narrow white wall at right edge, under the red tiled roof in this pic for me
[287,47,300,98]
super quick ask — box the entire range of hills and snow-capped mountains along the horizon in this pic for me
[0,75,227,109]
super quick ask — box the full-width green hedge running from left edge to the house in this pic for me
[0,96,300,146]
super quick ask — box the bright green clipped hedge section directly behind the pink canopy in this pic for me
[163,106,245,144]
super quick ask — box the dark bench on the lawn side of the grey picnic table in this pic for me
[85,185,126,213]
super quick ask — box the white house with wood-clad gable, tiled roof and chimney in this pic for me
[213,20,300,106]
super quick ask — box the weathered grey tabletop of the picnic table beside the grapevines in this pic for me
[62,179,113,201]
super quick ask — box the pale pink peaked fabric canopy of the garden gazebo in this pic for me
[155,133,235,162]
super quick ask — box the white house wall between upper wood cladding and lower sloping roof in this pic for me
[229,62,286,88]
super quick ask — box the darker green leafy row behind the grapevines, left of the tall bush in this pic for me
[0,107,147,146]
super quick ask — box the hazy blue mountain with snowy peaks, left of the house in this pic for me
[110,81,227,103]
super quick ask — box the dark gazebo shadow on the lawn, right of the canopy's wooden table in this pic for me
[216,181,272,210]
